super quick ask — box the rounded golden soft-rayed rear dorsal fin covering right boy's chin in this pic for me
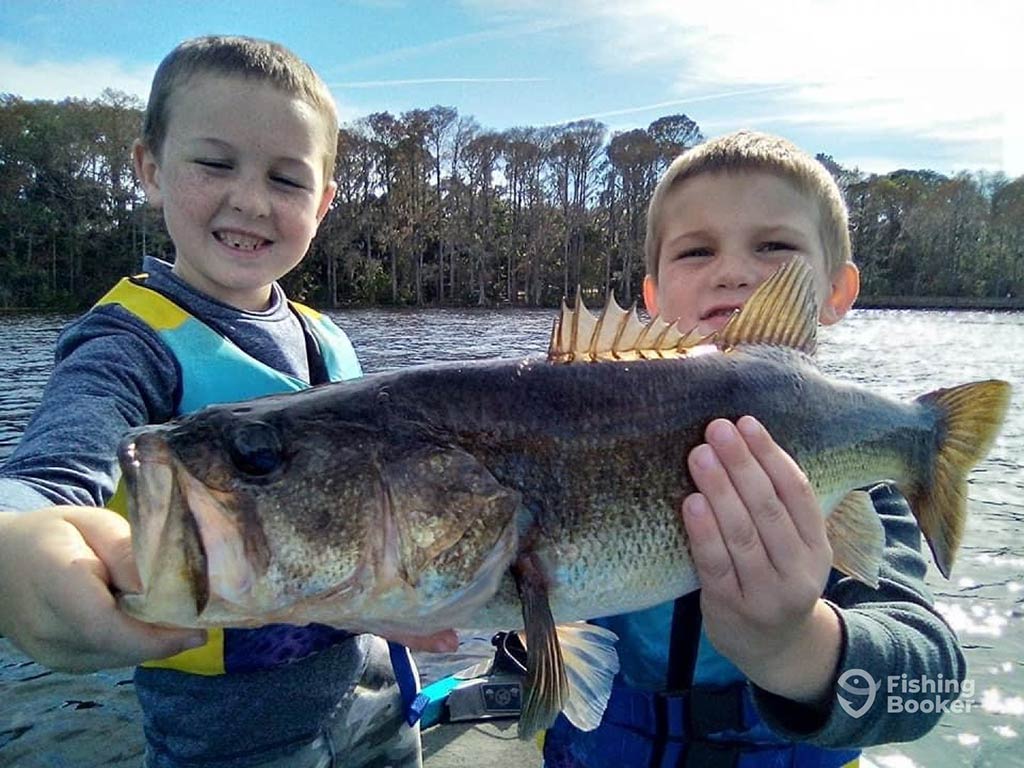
[717,257,818,354]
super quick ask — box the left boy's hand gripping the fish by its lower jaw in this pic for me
[0,507,205,672]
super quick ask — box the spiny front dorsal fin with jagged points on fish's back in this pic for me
[548,291,707,362]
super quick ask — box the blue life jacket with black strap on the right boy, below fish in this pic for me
[543,592,860,768]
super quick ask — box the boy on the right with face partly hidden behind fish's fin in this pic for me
[545,131,965,768]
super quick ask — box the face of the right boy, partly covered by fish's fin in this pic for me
[644,171,845,334]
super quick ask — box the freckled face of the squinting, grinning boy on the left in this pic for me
[135,75,336,310]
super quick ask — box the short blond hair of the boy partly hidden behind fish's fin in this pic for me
[644,130,851,281]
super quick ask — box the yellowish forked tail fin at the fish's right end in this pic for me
[909,380,1010,579]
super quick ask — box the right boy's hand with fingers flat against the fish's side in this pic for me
[683,417,842,703]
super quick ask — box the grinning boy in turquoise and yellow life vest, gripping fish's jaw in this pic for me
[0,37,456,768]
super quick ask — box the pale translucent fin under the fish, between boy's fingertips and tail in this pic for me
[825,490,886,589]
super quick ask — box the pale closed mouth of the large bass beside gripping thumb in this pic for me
[118,428,211,626]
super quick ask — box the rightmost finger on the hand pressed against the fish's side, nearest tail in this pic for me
[736,416,825,549]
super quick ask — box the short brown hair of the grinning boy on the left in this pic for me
[142,35,338,183]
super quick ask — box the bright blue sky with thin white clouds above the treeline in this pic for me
[0,0,1024,177]
